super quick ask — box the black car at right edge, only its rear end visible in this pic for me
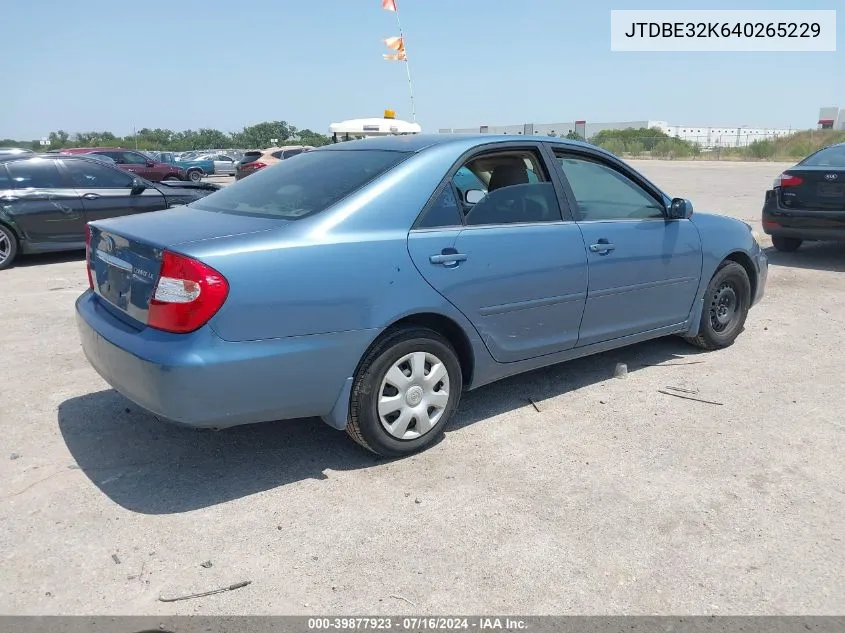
[763,143,845,252]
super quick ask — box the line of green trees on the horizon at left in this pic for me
[0,121,331,152]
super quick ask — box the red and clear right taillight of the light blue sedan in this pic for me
[147,251,229,334]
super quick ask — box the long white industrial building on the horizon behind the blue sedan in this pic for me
[440,118,804,149]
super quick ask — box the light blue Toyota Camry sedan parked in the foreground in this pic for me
[76,135,768,456]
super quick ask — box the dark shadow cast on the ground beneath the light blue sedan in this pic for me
[58,338,701,515]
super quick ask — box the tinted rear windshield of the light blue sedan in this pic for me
[189,150,410,220]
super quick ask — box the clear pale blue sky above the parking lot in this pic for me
[0,0,845,140]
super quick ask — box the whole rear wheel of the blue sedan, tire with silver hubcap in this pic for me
[346,326,463,457]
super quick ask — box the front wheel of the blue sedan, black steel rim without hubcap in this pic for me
[686,261,751,350]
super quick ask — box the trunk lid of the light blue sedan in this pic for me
[89,207,287,329]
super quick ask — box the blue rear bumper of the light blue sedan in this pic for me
[76,290,375,428]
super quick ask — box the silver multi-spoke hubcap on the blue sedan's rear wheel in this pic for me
[378,352,449,440]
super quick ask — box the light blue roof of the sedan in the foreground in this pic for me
[318,133,596,152]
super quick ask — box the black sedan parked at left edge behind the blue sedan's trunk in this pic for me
[0,154,220,270]
